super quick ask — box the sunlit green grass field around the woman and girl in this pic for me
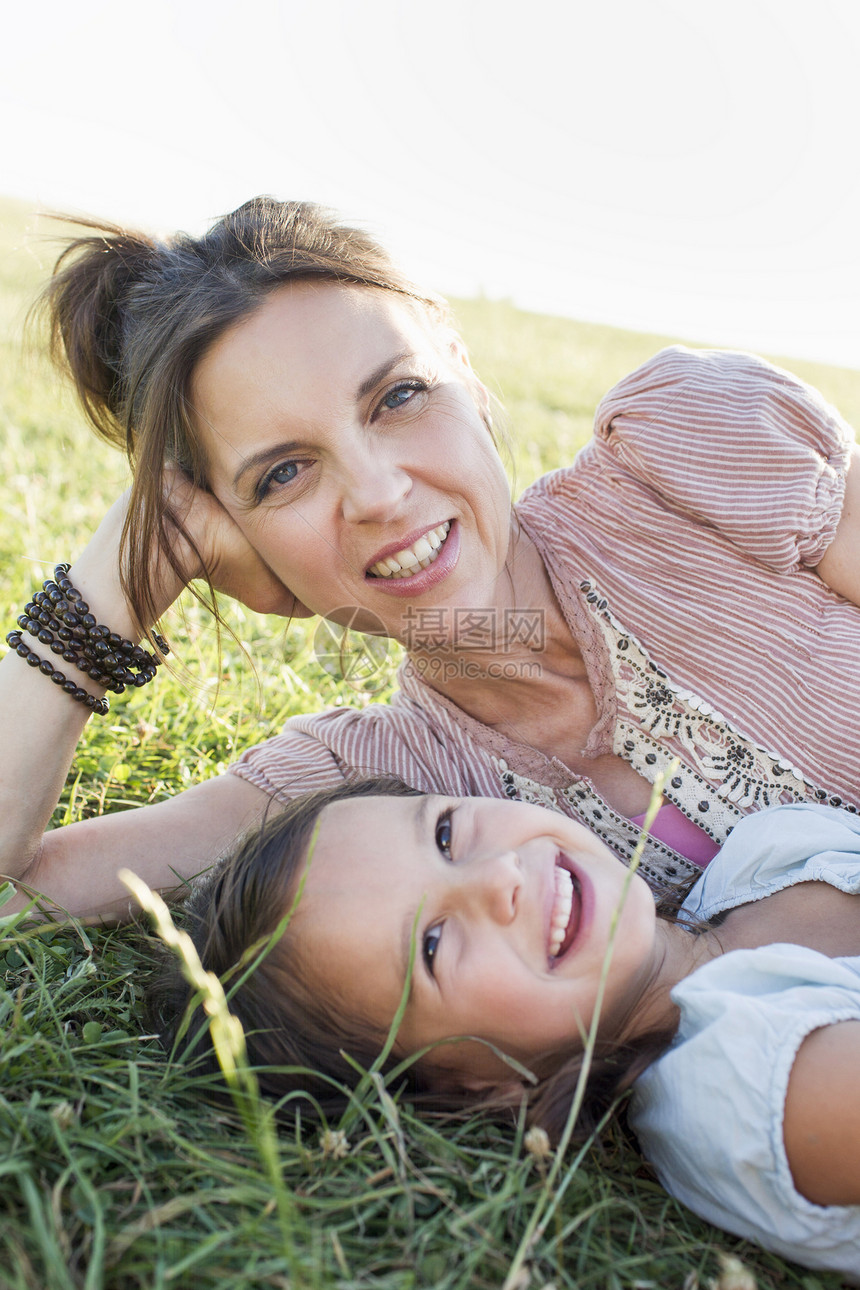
[0,193,860,1290]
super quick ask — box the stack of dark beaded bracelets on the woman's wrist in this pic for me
[6,564,170,716]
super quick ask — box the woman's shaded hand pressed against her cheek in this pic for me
[160,467,309,618]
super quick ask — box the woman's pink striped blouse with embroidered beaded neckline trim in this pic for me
[231,347,860,889]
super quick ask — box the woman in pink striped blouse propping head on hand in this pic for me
[0,199,860,913]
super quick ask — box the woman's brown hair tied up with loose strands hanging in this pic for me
[36,197,446,626]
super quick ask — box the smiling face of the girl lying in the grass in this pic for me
[295,797,661,1087]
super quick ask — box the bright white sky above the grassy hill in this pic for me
[0,0,860,368]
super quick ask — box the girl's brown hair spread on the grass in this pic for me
[150,779,672,1139]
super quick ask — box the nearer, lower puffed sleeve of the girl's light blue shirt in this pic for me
[630,944,860,1276]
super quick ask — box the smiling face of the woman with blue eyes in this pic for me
[192,281,511,639]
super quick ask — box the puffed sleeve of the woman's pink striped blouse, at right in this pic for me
[594,346,854,573]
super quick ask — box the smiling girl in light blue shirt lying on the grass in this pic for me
[149,780,860,1273]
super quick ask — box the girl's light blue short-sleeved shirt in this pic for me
[630,805,860,1277]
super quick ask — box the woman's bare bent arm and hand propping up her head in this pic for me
[0,472,302,917]
